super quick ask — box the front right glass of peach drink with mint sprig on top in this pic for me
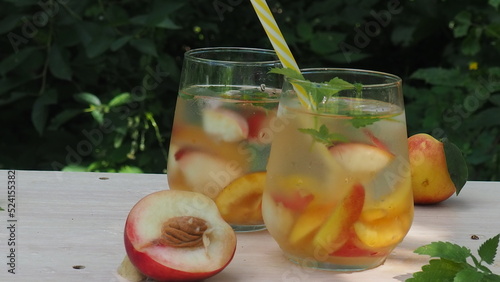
[262,69,413,271]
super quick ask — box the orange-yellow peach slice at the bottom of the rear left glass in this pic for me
[215,171,266,224]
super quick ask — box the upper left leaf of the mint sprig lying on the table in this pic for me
[413,241,471,263]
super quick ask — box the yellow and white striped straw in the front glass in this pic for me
[250,0,314,109]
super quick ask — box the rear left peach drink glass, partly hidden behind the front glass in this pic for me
[167,47,283,231]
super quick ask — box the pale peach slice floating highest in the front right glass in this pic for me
[329,143,394,179]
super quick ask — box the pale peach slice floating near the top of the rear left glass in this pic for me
[202,108,249,142]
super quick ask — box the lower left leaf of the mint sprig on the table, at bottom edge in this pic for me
[406,259,464,282]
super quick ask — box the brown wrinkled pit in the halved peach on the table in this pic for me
[157,216,208,248]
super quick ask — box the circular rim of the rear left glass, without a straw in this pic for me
[184,47,281,65]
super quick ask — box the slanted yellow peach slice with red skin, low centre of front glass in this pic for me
[313,184,365,253]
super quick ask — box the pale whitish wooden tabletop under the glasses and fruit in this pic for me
[0,170,500,282]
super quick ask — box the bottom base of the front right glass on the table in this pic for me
[285,253,386,272]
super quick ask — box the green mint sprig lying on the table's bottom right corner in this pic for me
[406,234,500,282]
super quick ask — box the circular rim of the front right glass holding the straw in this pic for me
[285,68,403,89]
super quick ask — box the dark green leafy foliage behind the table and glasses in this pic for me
[0,0,500,180]
